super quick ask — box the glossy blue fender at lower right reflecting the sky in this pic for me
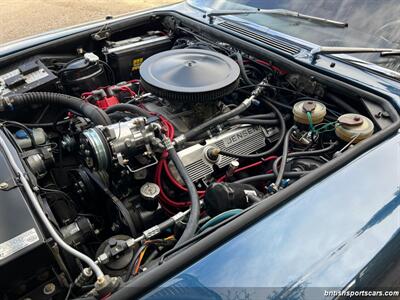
[145,135,400,299]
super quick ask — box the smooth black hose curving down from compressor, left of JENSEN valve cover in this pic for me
[168,139,200,247]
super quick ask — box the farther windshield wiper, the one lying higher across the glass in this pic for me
[205,8,349,28]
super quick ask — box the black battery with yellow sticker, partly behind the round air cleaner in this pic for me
[103,31,172,82]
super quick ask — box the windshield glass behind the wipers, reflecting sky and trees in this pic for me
[188,0,400,71]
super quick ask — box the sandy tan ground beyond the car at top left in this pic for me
[0,0,178,44]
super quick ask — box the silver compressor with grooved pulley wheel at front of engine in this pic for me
[80,117,161,173]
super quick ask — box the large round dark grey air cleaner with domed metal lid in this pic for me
[140,49,240,102]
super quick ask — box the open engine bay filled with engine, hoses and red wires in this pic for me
[0,14,390,299]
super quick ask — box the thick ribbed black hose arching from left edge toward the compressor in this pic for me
[8,92,111,125]
